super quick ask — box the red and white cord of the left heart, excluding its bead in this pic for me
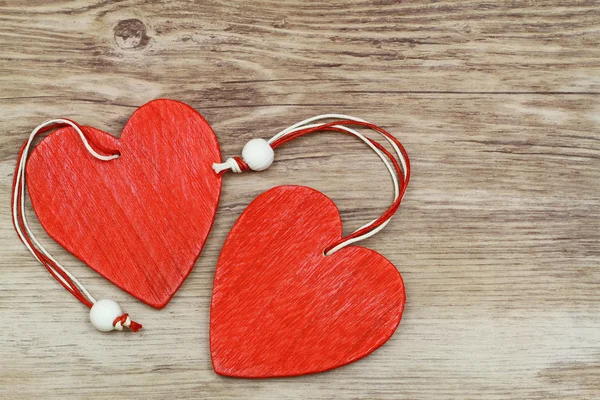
[11,119,142,332]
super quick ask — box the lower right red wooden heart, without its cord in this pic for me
[210,186,405,378]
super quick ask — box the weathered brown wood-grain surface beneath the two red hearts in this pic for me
[0,0,600,399]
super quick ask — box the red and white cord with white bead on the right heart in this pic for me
[213,114,410,255]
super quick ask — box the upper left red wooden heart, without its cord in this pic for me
[27,99,221,308]
